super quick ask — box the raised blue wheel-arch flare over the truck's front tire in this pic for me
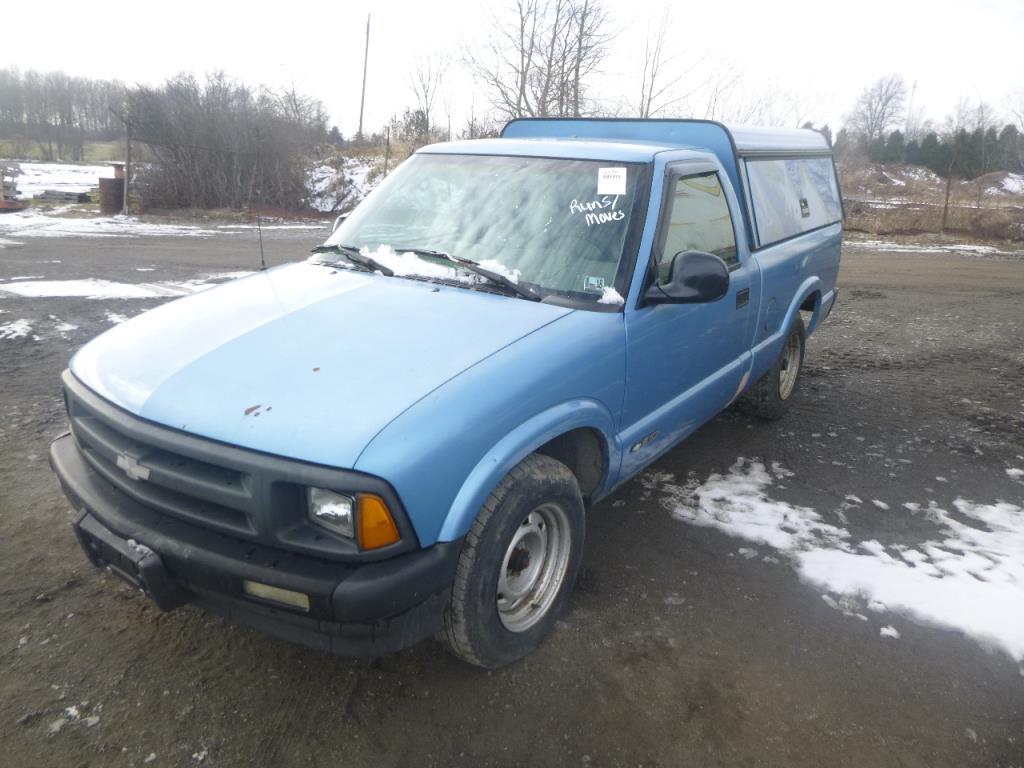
[437,399,622,542]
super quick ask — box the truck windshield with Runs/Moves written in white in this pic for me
[327,155,645,303]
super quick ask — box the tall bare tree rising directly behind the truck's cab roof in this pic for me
[467,0,609,119]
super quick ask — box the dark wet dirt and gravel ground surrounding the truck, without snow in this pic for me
[0,232,1024,768]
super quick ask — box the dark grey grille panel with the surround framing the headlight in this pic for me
[62,371,419,560]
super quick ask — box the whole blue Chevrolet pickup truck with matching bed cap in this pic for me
[50,119,843,668]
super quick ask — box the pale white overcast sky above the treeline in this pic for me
[0,0,1024,135]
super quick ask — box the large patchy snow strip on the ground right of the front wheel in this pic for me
[644,457,1024,675]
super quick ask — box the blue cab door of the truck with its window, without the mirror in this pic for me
[621,161,760,476]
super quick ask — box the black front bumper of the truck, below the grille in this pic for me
[50,434,461,655]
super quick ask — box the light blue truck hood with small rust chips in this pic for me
[71,263,571,467]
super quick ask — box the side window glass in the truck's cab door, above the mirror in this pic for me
[657,173,738,282]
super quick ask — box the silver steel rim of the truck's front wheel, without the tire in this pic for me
[496,504,571,632]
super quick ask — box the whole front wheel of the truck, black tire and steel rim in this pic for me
[443,454,586,669]
